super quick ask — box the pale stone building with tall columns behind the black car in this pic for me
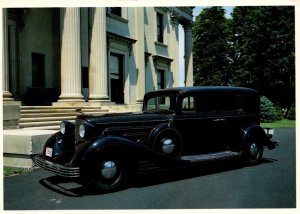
[2,7,193,128]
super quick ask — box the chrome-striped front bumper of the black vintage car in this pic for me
[34,155,80,178]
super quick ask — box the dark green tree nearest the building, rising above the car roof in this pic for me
[193,7,230,85]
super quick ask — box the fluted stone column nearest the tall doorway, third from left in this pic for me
[89,7,110,103]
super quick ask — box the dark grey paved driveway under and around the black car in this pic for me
[4,129,296,210]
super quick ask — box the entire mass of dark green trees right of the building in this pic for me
[193,6,295,108]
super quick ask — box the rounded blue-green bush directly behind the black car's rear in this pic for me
[260,96,281,122]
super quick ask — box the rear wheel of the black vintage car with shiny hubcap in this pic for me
[243,136,264,165]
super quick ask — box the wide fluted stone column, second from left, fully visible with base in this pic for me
[58,8,84,105]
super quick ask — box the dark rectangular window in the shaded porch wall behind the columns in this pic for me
[31,53,45,88]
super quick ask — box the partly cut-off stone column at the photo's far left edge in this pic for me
[1,9,13,101]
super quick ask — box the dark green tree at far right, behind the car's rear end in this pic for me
[230,6,295,107]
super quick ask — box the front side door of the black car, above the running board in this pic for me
[173,94,223,155]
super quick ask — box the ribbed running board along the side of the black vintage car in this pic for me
[181,151,241,163]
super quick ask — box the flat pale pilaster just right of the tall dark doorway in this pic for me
[135,7,146,103]
